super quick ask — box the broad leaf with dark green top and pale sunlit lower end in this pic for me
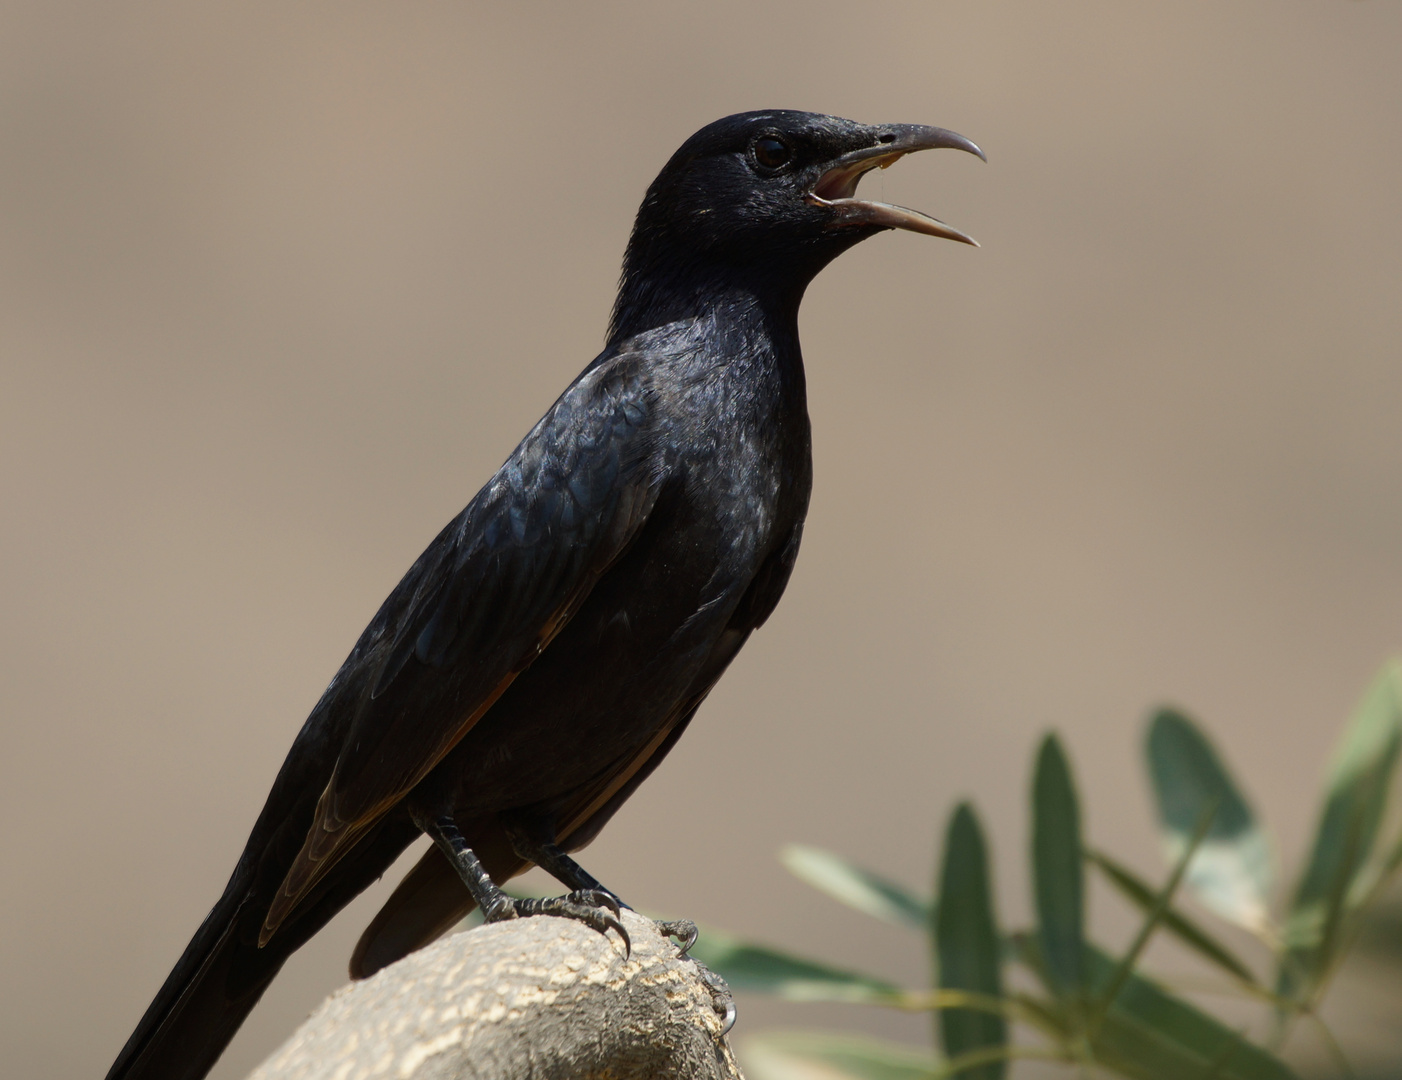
[1145,708,1273,933]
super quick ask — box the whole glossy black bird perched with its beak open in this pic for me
[108,111,983,1080]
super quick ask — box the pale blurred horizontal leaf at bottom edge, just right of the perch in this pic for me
[740,1031,939,1080]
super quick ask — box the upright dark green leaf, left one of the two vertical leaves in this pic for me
[931,802,1008,1080]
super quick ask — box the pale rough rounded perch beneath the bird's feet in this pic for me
[250,912,743,1080]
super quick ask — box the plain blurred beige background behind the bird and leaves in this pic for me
[0,0,1402,1080]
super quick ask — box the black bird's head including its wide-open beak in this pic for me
[614,109,983,336]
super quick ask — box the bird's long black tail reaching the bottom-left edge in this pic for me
[107,822,418,1080]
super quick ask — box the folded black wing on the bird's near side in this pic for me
[262,355,663,941]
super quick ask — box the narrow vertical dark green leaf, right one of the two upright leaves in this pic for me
[1032,735,1085,1001]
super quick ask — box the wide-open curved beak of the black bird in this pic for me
[806,123,988,247]
